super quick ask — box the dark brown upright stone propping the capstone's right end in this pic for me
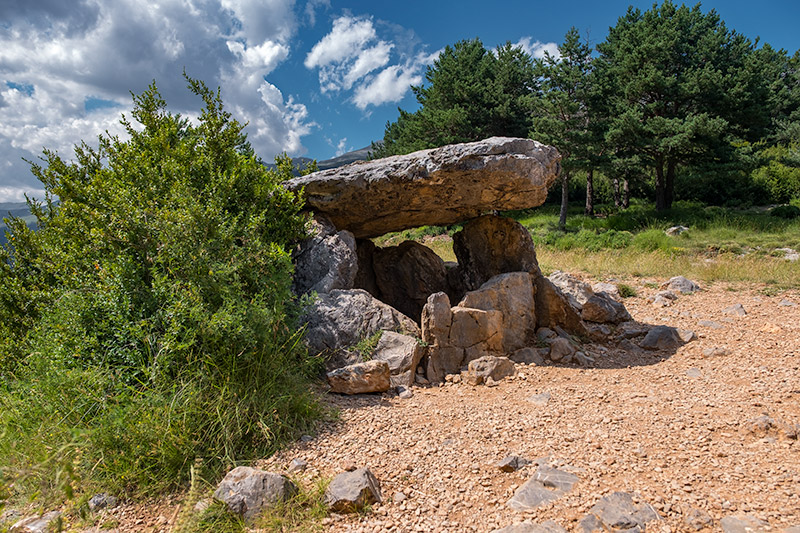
[453,215,540,290]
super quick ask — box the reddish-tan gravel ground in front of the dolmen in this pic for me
[69,279,800,533]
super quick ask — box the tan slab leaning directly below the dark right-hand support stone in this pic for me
[458,272,536,353]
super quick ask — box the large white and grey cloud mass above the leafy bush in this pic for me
[0,0,314,201]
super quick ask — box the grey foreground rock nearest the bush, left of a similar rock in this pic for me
[214,466,297,520]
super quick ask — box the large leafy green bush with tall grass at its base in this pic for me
[0,79,319,495]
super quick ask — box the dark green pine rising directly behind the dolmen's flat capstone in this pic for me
[373,39,534,157]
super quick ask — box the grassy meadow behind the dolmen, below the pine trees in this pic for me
[376,202,800,286]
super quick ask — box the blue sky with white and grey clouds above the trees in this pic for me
[0,0,800,202]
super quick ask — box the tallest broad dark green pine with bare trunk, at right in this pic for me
[598,0,769,210]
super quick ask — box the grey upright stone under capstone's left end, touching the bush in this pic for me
[293,215,358,294]
